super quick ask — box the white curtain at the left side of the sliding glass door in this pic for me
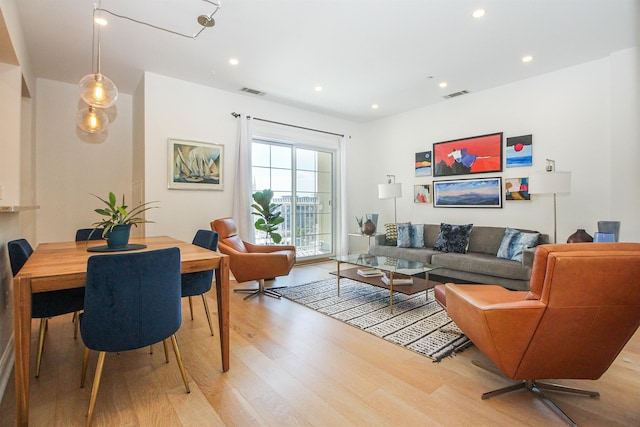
[232,114,255,243]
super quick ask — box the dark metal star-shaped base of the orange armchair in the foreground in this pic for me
[472,359,600,427]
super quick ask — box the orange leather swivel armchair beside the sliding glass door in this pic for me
[211,218,296,299]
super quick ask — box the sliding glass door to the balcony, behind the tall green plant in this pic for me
[251,138,335,261]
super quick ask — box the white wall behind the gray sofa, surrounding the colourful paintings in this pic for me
[354,54,640,241]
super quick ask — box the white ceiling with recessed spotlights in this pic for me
[16,0,640,121]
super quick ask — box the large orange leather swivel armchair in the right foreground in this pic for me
[440,243,640,425]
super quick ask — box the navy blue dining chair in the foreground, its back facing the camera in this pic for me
[80,248,190,426]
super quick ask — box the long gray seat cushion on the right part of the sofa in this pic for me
[431,252,531,280]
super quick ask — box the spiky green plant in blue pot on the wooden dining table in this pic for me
[92,192,156,249]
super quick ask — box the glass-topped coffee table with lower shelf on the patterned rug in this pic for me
[332,254,440,313]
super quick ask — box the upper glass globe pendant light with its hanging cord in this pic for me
[78,5,118,108]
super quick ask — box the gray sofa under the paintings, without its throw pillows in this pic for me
[369,224,549,290]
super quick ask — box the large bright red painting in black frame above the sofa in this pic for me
[433,132,502,176]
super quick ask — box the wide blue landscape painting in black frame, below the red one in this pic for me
[433,177,502,208]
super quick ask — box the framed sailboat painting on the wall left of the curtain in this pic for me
[168,139,224,190]
